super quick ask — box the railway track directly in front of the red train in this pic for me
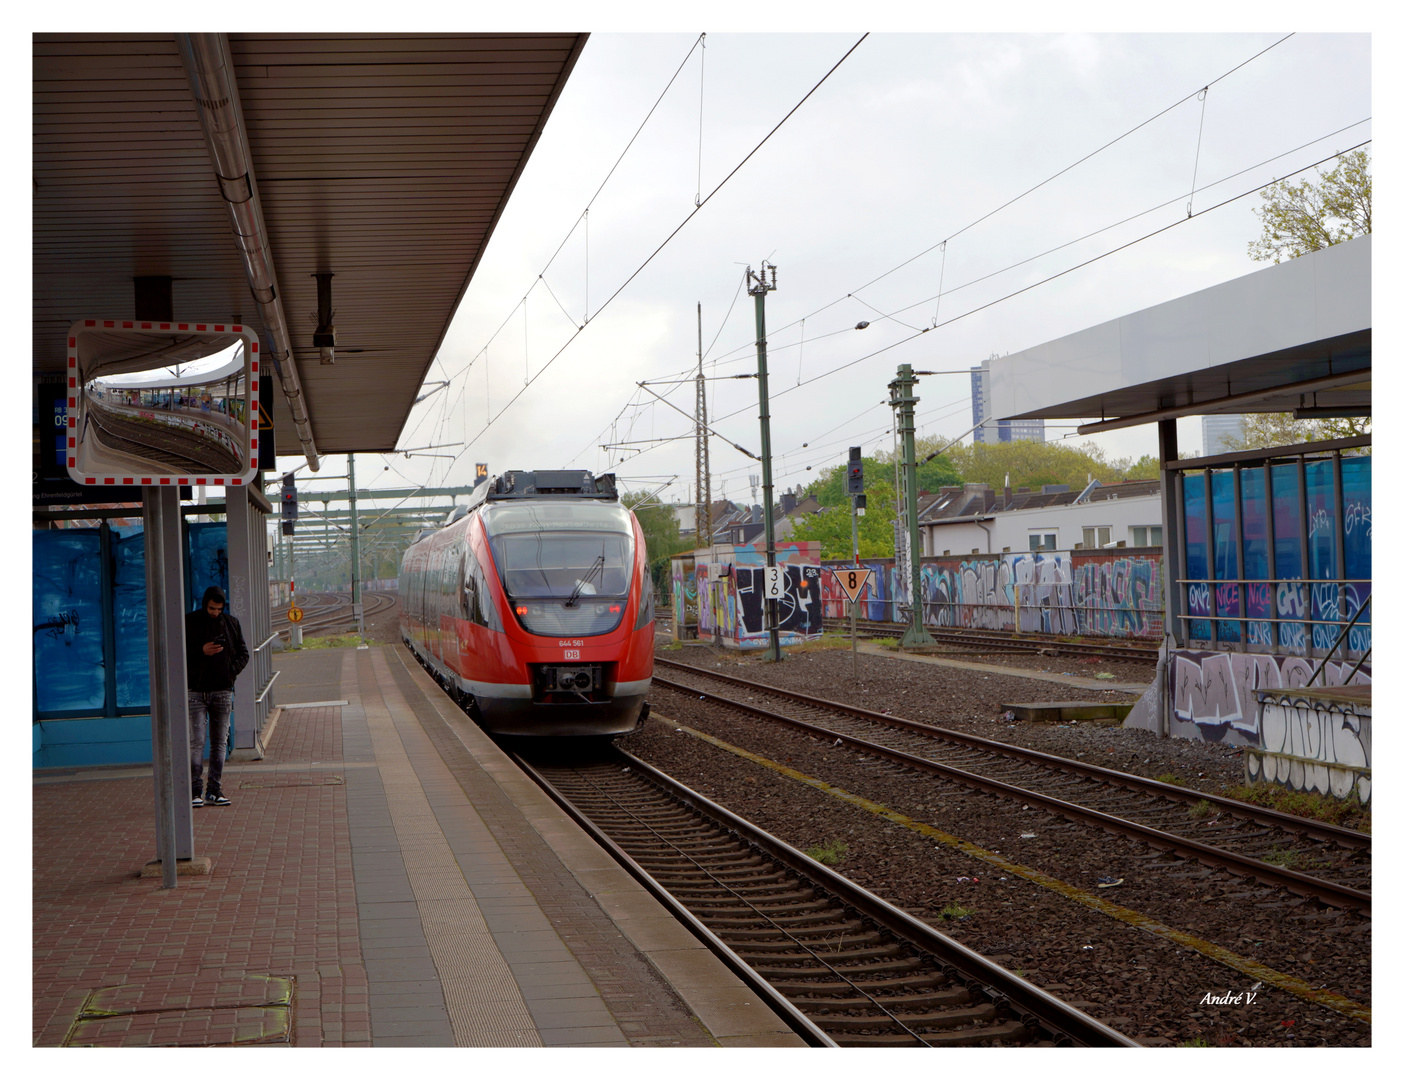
[517,747,1137,1046]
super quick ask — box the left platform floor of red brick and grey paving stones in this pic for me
[32,646,802,1048]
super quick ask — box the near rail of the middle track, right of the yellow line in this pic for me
[653,665,1370,914]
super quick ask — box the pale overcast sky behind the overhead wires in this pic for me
[285,31,1372,501]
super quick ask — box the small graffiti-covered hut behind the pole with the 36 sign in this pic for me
[673,541,824,649]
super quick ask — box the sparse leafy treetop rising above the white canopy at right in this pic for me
[1248,150,1370,263]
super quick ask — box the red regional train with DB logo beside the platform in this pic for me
[400,470,653,736]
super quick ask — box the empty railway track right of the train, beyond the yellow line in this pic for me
[653,659,1370,914]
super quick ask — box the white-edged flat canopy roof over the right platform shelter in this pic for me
[990,236,1372,434]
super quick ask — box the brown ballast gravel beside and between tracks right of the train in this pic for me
[618,646,1370,1046]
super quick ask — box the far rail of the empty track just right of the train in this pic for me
[653,657,1372,851]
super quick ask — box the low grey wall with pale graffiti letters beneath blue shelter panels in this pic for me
[1168,650,1372,746]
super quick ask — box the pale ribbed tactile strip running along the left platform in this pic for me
[364,657,542,1046]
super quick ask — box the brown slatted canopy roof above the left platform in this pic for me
[32,34,585,455]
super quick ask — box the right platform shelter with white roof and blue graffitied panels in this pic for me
[977,235,1370,802]
